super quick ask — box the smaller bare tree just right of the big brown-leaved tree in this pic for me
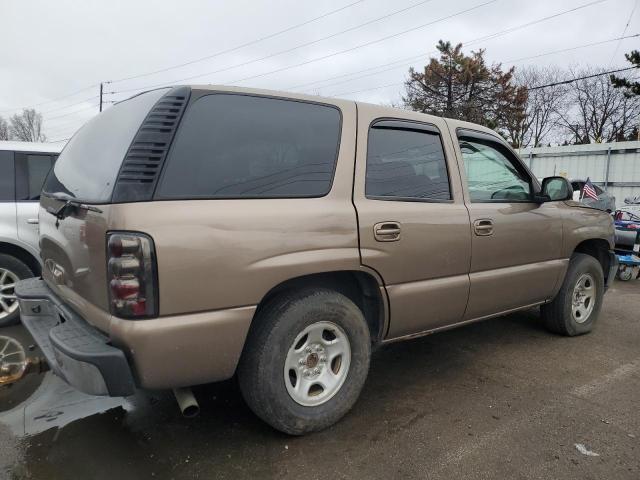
[508,66,567,147]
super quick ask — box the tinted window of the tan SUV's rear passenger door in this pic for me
[365,121,451,201]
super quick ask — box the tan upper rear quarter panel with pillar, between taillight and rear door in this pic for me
[110,101,360,316]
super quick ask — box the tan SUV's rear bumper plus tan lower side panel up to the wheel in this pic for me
[15,278,256,396]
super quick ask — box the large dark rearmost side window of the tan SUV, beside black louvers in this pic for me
[157,94,341,199]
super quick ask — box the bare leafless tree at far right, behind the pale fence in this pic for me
[558,69,640,143]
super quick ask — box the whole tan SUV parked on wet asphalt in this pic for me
[16,86,616,434]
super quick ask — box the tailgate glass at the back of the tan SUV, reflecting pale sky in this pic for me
[43,89,168,203]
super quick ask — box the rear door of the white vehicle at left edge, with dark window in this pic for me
[15,152,57,249]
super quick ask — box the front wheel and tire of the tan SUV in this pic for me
[541,253,604,336]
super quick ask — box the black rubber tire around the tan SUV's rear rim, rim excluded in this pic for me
[238,289,371,435]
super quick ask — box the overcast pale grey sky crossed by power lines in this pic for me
[0,0,640,140]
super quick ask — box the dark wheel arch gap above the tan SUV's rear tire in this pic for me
[250,270,386,343]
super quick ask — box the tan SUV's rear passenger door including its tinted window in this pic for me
[354,105,471,338]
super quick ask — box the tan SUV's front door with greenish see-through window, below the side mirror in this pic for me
[457,130,566,320]
